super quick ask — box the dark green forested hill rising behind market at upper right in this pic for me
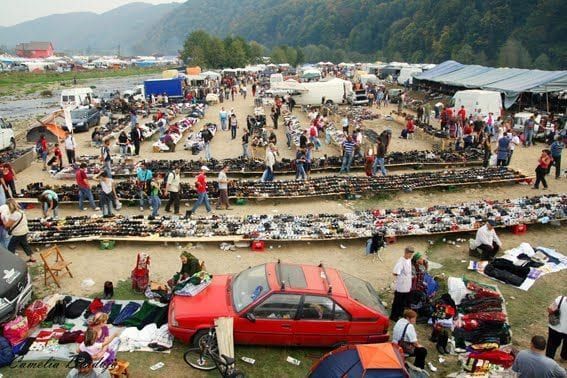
[136,0,567,69]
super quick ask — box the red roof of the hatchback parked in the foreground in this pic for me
[266,262,348,297]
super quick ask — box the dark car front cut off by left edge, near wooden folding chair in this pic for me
[0,246,32,323]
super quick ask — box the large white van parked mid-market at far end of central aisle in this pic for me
[293,78,352,105]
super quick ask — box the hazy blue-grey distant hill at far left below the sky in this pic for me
[0,3,179,54]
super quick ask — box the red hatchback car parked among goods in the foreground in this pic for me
[168,262,389,347]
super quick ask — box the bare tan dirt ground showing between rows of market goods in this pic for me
[5,86,567,376]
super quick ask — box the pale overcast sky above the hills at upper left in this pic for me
[0,0,184,26]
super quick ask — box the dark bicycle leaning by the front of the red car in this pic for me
[183,328,245,378]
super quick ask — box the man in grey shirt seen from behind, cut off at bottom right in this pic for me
[512,335,567,378]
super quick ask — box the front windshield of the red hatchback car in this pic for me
[232,265,269,312]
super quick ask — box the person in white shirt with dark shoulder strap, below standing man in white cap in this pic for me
[392,309,430,371]
